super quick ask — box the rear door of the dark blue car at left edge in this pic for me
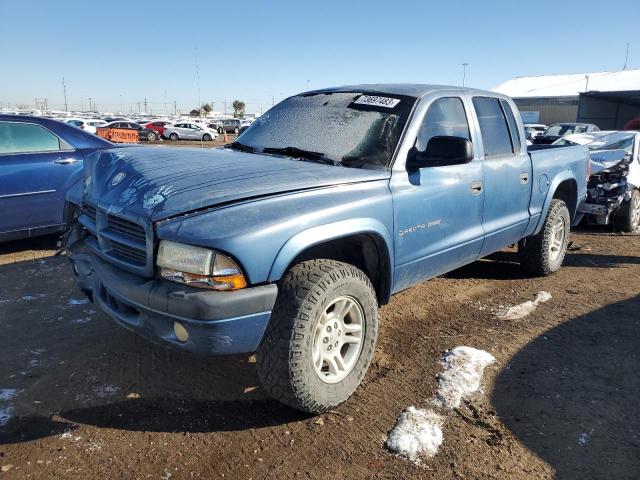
[0,121,82,233]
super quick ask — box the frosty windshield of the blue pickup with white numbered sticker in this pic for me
[238,92,416,167]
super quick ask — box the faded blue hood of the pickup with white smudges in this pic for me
[83,147,390,222]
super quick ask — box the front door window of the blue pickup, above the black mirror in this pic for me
[416,97,471,152]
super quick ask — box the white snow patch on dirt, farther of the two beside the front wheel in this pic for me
[436,347,496,409]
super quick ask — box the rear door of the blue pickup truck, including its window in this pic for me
[472,96,532,256]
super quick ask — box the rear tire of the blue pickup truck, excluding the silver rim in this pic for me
[518,198,571,276]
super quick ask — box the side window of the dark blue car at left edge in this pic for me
[0,122,60,154]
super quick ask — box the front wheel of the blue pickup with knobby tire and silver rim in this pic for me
[256,259,378,413]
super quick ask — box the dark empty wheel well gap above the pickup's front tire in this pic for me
[287,234,391,305]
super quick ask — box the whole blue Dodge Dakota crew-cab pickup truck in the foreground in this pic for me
[64,85,589,413]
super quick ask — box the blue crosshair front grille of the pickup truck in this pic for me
[80,204,153,276]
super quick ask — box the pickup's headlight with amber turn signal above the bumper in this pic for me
[156,240,247,290]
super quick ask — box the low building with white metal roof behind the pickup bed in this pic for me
[493,70,640,130]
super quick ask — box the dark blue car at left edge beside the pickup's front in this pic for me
[0,115,114,241]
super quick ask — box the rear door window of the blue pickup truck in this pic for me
[473,97,513,157]
